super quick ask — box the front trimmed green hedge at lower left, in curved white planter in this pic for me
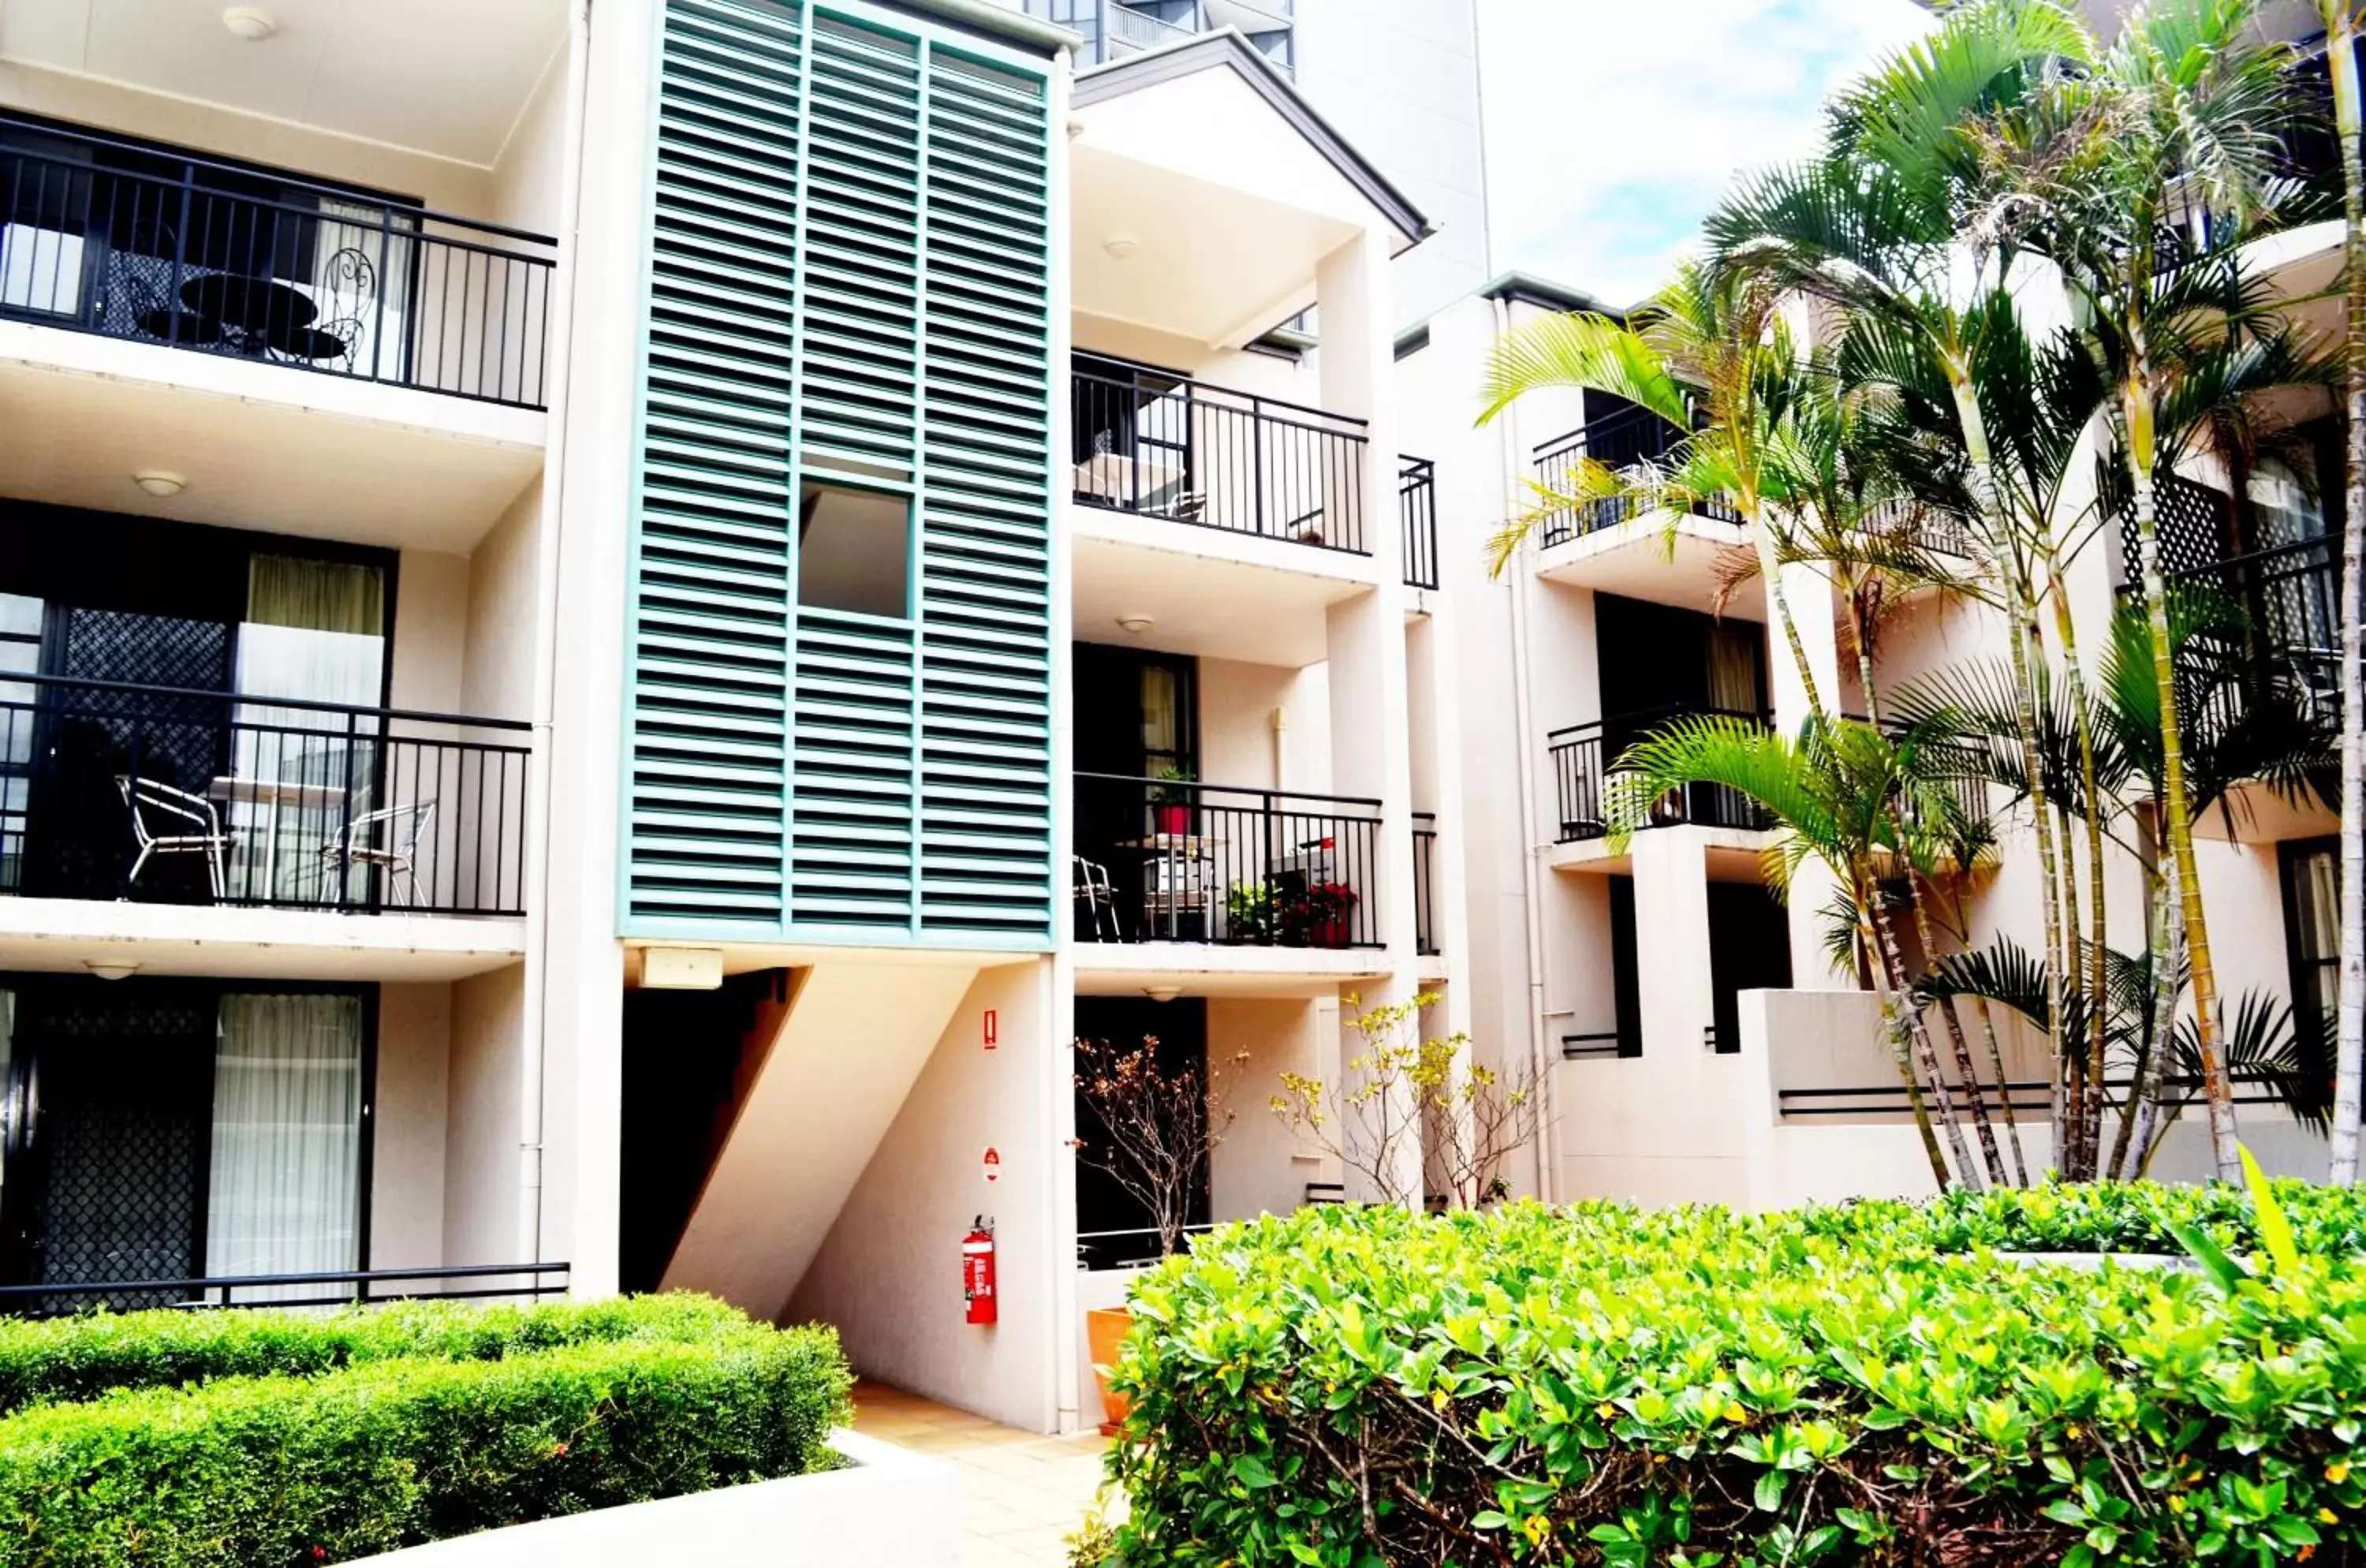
[0,1320,852,1568]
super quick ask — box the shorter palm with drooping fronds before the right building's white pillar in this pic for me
[1604,715,1980,1187]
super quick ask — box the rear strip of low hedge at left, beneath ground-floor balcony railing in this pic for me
[0,1294,748,1414]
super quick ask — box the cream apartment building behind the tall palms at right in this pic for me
[1398,21,2342,1206]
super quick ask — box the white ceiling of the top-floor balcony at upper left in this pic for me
[0,0,568,166]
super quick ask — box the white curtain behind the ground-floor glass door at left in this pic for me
[206,993,362,1301]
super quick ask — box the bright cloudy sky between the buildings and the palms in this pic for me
[1479,0,1931,305]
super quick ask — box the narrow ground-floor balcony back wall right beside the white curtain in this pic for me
[364,984,452,1267]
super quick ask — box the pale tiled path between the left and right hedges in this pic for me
[854,1383,1107,1568]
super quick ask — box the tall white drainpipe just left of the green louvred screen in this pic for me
[518,0,592,1263]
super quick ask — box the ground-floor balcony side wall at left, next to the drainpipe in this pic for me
[442,965,523,1263]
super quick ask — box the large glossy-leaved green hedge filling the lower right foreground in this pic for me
[1110,1194,2366,1568]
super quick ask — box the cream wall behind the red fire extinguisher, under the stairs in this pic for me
[783,960,1060,1431]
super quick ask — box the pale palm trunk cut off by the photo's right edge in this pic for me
[2321,0,2366,1187]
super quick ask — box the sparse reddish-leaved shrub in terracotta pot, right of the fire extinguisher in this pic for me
[1069,1036,1249,1435]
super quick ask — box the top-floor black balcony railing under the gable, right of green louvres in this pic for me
[1069,362,1370,556]
